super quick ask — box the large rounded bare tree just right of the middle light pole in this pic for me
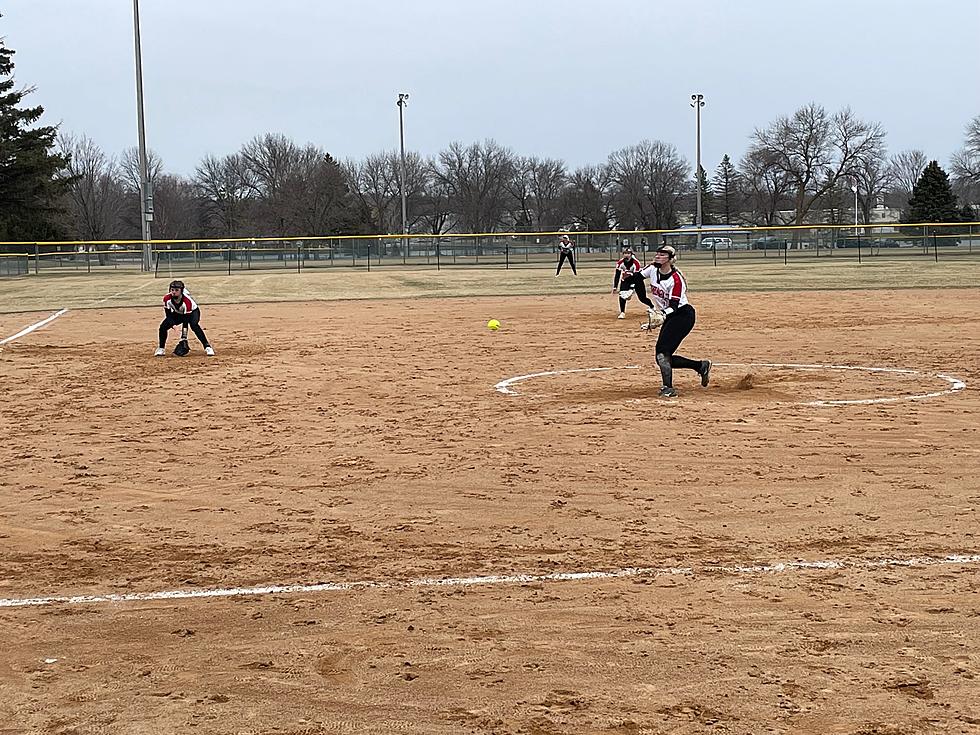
[435,139,514,232]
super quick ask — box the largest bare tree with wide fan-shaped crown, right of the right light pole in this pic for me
[749,103,885,225]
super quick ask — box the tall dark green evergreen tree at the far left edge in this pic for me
[0,30,68,240]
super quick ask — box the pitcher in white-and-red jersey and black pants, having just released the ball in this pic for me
[640,244,711,398]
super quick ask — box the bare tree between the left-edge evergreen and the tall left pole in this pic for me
[58,135,126,247]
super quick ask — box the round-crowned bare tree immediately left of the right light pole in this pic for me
[606,140,691,230]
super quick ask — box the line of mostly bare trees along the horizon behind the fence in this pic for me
[0,32,980,247]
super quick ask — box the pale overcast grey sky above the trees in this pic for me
[0,0,980,174]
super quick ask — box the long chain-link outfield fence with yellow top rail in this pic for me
[0,223,980,277]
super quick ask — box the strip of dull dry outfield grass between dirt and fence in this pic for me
[0,258,980,313]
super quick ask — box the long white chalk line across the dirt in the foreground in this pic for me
[0,554,980,608]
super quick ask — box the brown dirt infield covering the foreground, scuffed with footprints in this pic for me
[0,290,980,735]
